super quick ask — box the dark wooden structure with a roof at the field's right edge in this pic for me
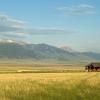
[85,63,100,72]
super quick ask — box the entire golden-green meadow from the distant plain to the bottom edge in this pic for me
[0,60,100,100]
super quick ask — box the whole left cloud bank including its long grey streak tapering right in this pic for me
[0,14,77,40]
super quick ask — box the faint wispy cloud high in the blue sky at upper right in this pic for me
[57,4,96,15]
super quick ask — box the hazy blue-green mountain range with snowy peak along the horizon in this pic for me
[0,41,100,62]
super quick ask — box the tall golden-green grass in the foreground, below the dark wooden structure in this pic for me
[0,72,100,100]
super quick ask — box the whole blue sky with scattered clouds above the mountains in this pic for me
[0,0,100,53]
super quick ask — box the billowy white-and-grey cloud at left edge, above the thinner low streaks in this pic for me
[0,14,25,32]
